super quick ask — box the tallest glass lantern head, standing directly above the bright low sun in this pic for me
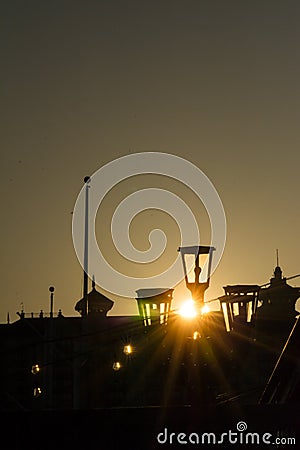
[178,245,215,312]
